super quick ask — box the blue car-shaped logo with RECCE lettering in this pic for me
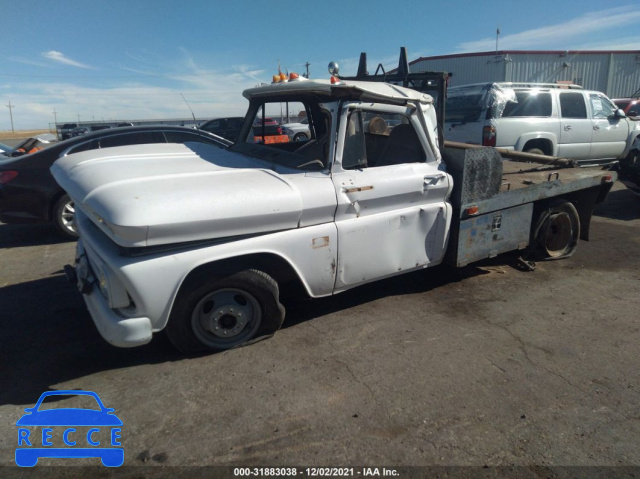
[16,390,124,467]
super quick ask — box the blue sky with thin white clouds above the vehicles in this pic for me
[0,0,640,131]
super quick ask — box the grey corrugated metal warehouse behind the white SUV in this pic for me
[409,50,640,98]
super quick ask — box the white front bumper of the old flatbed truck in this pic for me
[65,240,152,348]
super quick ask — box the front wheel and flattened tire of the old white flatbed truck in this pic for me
[166,270,284,354]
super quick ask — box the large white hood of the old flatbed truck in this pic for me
[51,143,302,247]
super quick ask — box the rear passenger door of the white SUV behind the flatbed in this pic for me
[557,92,593,160]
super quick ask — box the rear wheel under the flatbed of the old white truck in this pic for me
[534,200,580,260]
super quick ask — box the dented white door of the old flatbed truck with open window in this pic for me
[332,106,451,291]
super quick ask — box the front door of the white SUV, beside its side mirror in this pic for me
[589,93,629,159]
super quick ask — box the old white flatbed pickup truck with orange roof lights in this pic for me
[51,72,616,353]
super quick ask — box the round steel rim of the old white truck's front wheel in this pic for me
[191,288,262,347]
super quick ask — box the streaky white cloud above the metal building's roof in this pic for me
[457,6,640,52]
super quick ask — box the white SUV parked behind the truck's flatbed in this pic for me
[444,83,640,162]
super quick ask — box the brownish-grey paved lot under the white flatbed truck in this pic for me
[0,184,640,477]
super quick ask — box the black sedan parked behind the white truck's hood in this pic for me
[0,125,232,237]
